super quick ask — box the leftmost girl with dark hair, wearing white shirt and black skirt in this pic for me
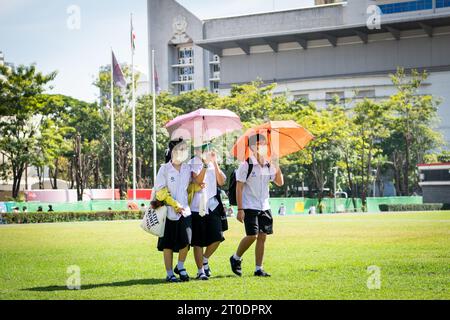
[155,139,192,282]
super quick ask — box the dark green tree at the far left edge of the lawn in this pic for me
[0,65,56,198]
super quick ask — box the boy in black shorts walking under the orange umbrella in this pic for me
[230,134,284,277]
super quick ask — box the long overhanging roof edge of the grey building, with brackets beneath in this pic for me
[195,12,450,55]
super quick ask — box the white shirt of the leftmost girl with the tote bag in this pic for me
[155,162,191,221]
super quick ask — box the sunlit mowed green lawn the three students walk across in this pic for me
[0,212,450,300]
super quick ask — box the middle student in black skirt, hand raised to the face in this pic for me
[189,144,226,280]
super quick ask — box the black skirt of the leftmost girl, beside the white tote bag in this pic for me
[158,216,192,252]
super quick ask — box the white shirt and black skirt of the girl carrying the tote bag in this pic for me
[155,162,192,252]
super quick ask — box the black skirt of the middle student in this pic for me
[191,207,225,248]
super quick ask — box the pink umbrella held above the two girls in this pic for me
[166,109,242,145]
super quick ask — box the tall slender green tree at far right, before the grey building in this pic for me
[383,68,443,196]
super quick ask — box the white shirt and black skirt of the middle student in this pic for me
[189,157,226,247]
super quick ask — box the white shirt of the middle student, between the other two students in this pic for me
[189,157,226,214]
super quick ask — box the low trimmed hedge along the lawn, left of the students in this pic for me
[0,211,144,224]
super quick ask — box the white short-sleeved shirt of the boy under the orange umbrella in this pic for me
[236,156,276,211]
